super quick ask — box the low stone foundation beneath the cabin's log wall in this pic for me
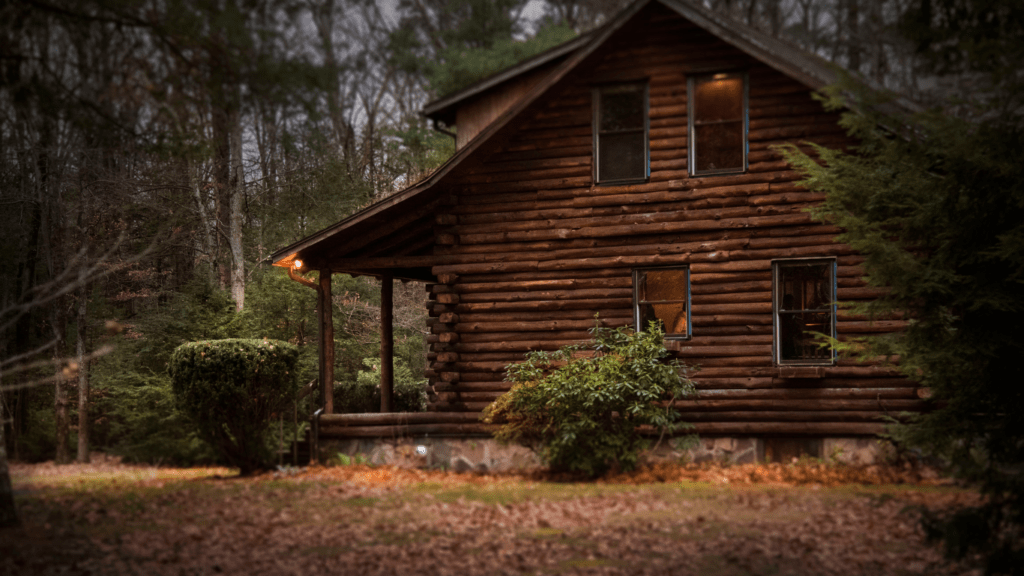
[319,437,892,472]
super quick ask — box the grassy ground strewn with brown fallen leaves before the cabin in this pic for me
[6,455,977,576]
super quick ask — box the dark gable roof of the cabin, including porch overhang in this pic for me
[270,0,913,280]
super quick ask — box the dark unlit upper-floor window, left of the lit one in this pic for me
[594,84,648,183]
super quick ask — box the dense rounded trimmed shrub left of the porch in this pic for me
[169,339,299,476]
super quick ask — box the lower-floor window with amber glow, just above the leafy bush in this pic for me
[633,268,690,340]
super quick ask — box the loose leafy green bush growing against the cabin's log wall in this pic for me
[484,323,694,477]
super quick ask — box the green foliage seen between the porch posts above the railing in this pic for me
[334,358,427,414]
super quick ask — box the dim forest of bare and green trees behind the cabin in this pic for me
[0,0,1007,464]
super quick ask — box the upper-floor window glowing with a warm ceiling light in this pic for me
[687,73,748,175]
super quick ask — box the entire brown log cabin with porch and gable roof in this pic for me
[272,0,924,456]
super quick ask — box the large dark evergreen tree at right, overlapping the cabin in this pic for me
[786,0,1024,561]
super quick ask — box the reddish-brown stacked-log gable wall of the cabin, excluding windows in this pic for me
[419,5,923,436]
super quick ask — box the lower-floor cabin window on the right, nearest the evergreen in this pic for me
[773,259,836,364]
